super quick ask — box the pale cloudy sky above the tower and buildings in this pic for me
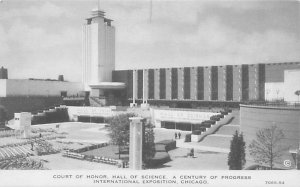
[0,0,300,82]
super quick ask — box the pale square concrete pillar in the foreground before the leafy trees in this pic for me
[129,117,143,170]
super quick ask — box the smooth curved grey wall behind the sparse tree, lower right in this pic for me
[240,105,300,169]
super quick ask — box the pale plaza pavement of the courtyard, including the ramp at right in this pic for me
[4,110,239,170]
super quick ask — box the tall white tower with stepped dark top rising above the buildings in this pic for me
[82,8,115,91]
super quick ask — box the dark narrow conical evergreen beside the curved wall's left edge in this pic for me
[227,131,246,170]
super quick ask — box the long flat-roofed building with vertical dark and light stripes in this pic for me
[112,62,300,106]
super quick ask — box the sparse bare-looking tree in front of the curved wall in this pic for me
[249,126,284,169]
